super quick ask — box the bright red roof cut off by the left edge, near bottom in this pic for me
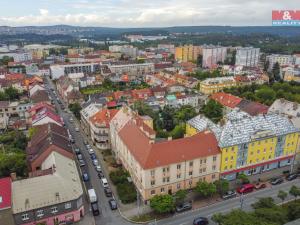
[0,177,12,210]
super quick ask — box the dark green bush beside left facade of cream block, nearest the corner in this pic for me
[117,181,137,204]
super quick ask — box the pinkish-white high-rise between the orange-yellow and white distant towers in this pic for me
[202,46,227,68]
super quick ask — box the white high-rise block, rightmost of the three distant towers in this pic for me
[235,47,260,67]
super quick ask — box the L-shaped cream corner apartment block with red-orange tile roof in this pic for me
[111,108,221,203]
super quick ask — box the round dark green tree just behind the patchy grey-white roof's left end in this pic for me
[201,99,223,123]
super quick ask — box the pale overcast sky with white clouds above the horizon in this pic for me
[0,0,300,27]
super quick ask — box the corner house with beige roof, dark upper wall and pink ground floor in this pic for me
[12,151,84,225]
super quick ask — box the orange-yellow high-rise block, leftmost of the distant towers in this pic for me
[175,45,201,62]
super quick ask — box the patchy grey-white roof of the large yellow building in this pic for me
[187,110,299,148]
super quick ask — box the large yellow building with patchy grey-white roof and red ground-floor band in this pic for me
[186,110,299,180]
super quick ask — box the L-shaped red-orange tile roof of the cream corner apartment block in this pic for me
[119,121,220,169]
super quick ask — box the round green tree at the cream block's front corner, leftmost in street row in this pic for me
[150,194,175,214]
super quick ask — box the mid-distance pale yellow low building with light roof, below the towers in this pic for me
[199,77,237,95]
